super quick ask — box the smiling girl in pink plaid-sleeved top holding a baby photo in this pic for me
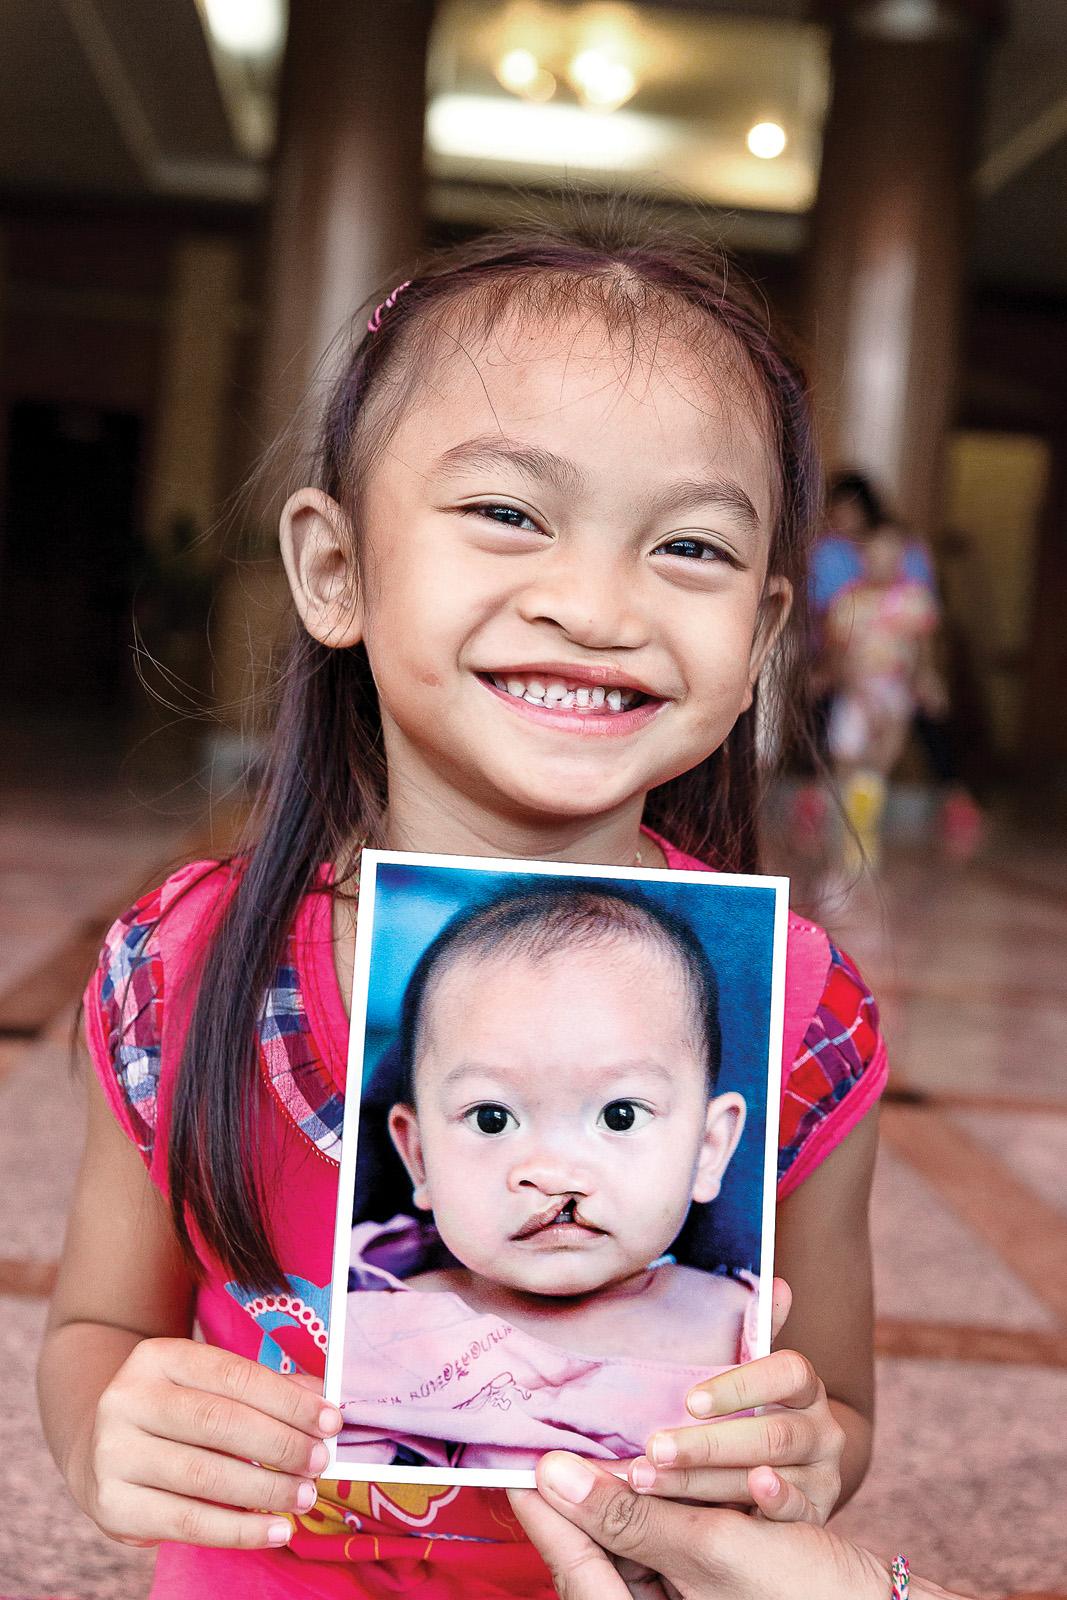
[40,216,885,1600]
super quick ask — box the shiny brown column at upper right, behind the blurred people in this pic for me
[808,0,997,531]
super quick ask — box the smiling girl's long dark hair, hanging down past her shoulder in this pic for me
[170,212,822,1288]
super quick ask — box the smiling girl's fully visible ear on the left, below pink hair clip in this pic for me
[278,488,363,650]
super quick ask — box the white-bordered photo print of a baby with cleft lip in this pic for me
[326,850,787,1486]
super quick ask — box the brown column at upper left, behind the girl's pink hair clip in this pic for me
[214,0,434,773]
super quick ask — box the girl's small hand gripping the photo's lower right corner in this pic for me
[627,1278,845,1523]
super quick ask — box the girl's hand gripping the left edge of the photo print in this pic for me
[74,1339,341,1549]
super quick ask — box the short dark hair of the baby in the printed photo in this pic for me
[398,877,723,1104]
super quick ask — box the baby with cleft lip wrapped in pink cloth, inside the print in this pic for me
[341,877,757,1467]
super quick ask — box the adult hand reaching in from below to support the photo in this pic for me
[510,1451,895,1600]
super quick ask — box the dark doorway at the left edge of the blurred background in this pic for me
[0,402,142,722]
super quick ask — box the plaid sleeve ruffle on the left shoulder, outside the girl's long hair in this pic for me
[86,888,163,1163]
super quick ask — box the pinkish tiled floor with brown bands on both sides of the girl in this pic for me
[0,782,1067,1600]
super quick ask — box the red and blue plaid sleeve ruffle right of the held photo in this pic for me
[777,944,885,1186]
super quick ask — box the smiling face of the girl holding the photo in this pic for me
[281,305,787,844]
